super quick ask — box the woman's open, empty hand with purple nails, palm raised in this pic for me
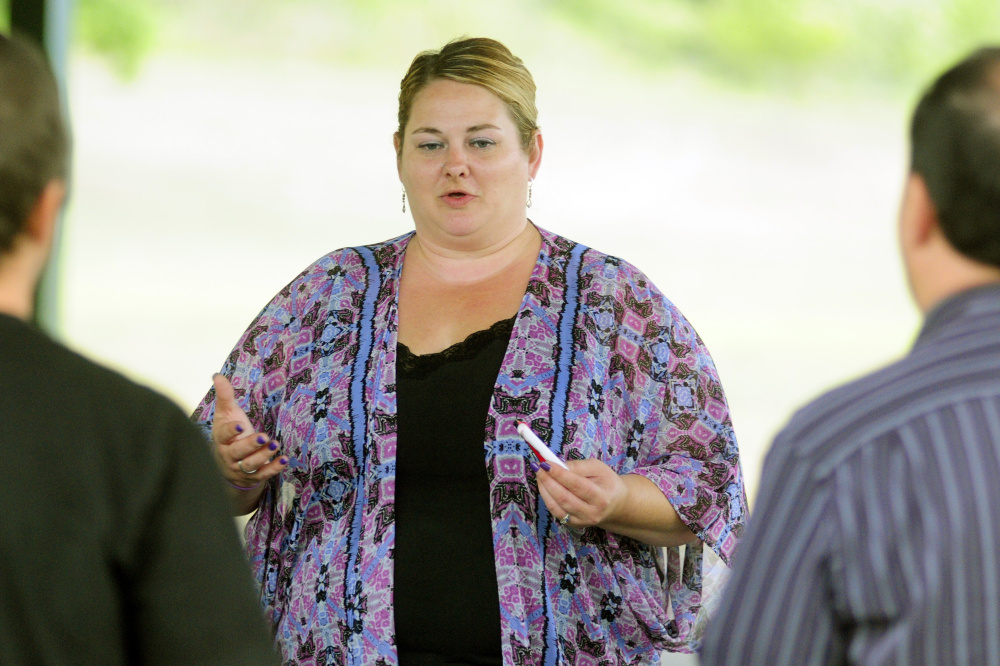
[212,374,288,513]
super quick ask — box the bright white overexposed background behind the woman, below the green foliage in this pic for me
[60,27,918,504]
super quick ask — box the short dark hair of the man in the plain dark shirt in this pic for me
[0,34,69,254]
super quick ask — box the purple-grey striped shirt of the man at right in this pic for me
[702,285,1000,664]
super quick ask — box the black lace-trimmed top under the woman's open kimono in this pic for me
[393,317,514,666]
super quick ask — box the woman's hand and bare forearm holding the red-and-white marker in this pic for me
[531,458,697,546]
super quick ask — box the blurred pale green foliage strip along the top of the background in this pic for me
[25,0,1000,91]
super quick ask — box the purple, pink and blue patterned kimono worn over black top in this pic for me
[195,226,747,666]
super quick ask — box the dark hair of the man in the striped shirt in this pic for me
[910,47,1000,266]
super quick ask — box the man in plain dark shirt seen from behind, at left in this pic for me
[0,35,278,666]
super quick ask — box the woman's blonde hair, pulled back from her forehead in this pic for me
[397,37,538,151]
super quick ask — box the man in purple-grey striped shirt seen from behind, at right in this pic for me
[701,47,1000,664]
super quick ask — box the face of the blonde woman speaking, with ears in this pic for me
[394,79,542,249]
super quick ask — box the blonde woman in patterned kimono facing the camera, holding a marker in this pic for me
[195,39,746,666]
